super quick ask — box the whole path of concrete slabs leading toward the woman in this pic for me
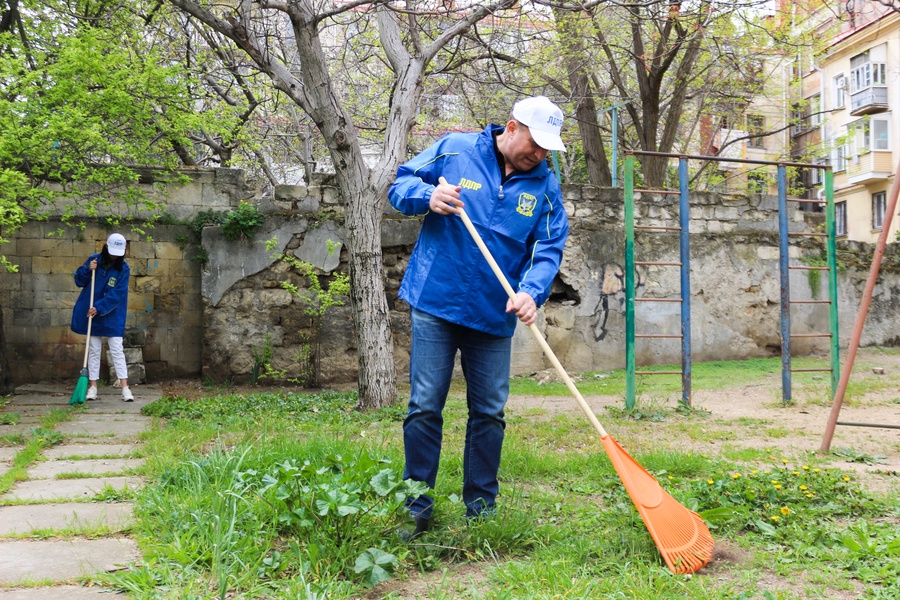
[0,381,160,600]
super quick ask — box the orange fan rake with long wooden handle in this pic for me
[440,177,715,574]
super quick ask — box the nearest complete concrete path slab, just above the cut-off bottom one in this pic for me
[0,538,140,585]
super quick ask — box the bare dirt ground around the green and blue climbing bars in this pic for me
[508,348,900,493]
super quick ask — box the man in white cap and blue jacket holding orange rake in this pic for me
[388,96,569,536]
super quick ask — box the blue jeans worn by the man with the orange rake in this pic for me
[403,309,512,518]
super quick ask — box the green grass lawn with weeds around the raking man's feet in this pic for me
[95,352,900,600]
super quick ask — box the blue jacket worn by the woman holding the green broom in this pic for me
[72,254,131,337]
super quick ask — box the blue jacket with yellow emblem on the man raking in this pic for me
[388,125,569,337]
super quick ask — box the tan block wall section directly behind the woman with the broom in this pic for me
[0,169,245,384]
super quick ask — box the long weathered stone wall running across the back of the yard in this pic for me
[0,170,900,385]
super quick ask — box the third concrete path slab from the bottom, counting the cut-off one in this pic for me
[0,502,134,536]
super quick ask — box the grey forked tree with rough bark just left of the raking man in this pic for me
[169,0,515,409]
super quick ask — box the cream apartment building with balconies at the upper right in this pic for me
[791,0,900,242]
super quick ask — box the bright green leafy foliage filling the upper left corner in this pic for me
[0,0,246,268]
